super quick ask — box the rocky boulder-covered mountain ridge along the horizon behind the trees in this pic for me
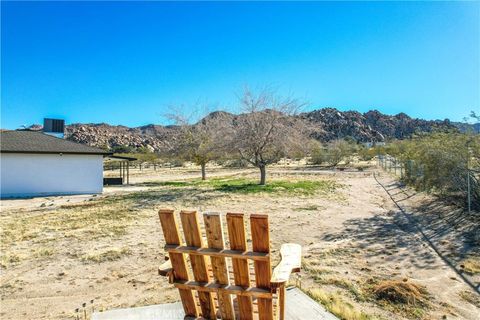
[26,108,457,151]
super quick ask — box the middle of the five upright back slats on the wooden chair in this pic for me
[203,213,235,320]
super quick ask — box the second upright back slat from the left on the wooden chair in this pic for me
[180,211,216,319]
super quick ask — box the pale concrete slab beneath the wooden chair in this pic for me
[92,288,338,320]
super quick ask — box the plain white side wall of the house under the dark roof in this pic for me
[0,153,103,198]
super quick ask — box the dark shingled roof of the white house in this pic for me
[0,130,111,155]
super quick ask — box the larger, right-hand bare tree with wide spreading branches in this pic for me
[228,88,306,185]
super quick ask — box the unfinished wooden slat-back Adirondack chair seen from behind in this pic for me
[158,209,301,320]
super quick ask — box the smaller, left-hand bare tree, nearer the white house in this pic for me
[167,112,225,180]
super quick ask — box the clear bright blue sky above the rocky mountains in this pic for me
[1,1,480,129]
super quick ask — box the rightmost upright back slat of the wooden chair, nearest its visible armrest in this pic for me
[250,214,273,320]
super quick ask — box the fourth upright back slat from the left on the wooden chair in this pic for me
[227,213,253,320]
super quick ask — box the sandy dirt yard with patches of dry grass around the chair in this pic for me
[0,159,478,319]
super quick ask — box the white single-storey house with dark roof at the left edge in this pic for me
[0,131,111,198]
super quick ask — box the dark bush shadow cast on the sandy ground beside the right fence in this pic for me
[324,179,480,291]
